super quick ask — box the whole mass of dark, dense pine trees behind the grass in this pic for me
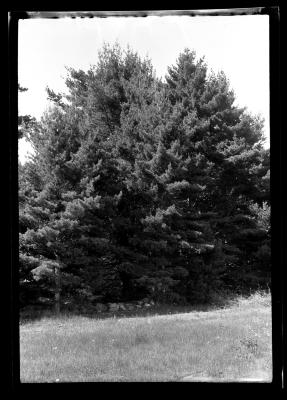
[19,45,270,308]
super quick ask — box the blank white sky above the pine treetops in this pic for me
[18,15,269,162]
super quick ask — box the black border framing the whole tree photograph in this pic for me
[7,2,287,396]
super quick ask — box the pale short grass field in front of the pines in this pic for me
[20,293,272,383]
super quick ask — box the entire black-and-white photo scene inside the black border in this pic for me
[18,10,273,383]
